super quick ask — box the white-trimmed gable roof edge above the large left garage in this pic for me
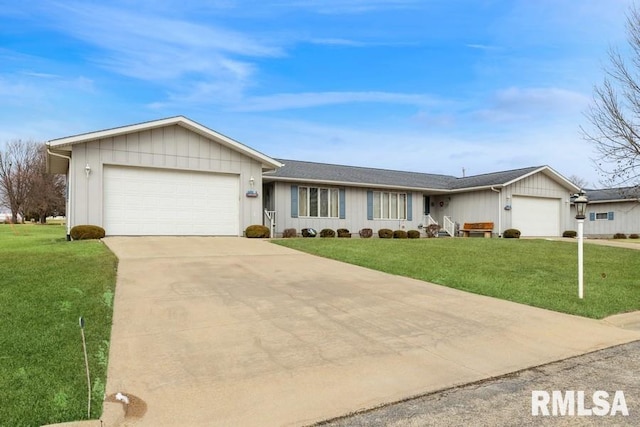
[47,116,282,169]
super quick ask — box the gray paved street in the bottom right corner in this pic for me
[322,341,640,427]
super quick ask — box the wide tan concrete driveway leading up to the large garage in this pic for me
[103,237,640,426]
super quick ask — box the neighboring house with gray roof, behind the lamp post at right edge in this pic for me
[571,187,640,238]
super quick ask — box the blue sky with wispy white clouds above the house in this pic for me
[0,0,631,186]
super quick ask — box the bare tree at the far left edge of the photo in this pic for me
[0,140,37,223]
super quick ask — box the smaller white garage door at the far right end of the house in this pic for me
[511,196,560,236]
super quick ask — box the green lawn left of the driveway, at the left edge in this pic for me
[0,225,117,426]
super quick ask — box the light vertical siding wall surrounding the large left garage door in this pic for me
[70,125,262,235]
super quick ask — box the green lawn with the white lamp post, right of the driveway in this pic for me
[273,238,640,319]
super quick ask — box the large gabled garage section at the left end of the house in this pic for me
[47,116,281,236]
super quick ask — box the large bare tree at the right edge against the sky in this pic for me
[581,6,640,191]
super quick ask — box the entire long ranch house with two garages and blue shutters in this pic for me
[47,116,579,236]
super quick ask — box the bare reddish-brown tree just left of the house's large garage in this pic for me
[25,144,65,224]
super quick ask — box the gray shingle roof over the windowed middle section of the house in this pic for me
[264,159,540,190]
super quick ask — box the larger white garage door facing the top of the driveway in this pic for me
[103,166,240,236]
